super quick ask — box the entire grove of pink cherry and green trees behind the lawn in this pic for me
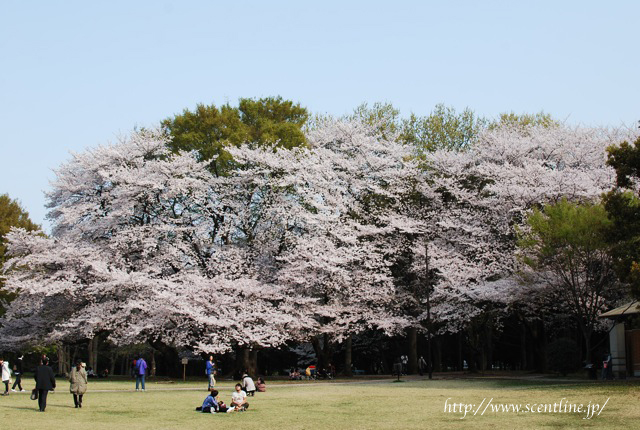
[0,97,640,382]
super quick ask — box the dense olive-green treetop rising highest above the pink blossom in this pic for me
[162,97,309,175]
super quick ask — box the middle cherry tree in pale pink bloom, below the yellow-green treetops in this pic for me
[225,119,424,372]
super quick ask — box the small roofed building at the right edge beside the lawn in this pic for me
[600,301,640,379]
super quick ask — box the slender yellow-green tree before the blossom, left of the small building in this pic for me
[518,199,621,362]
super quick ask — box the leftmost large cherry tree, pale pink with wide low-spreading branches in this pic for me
[5,130,304,351]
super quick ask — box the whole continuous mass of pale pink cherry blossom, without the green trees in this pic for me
[2,112,622,374]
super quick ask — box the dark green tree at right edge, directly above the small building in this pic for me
[603,138,640,298]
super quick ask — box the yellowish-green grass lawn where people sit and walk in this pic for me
[0,379,640,430]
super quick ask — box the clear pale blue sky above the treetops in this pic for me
[0,0,640,229]
